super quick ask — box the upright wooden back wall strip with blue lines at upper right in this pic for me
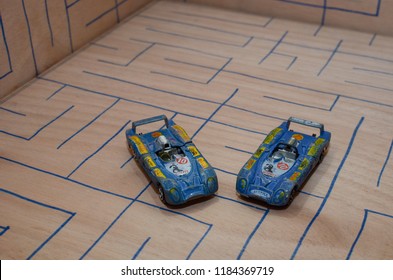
[179,0,393,36]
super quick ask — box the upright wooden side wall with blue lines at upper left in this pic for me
[0,0,150,99]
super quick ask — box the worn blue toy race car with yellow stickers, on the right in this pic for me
[236,117,331,206]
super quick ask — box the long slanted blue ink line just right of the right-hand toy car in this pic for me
[291,117,364,260]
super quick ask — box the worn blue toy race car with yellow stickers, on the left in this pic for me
[126,115,218,205]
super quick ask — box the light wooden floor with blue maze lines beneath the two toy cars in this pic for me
[0,2,393,259]
